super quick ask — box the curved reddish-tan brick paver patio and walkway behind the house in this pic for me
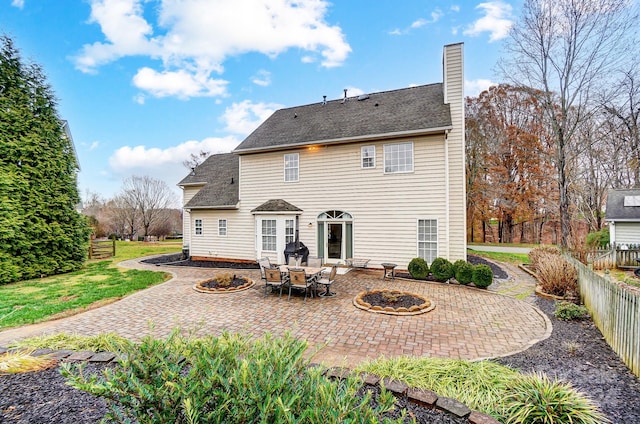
[0,260,551,367]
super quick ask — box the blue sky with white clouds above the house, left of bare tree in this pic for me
[0,0,521,204]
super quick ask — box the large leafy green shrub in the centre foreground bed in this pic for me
[61,330,394,424]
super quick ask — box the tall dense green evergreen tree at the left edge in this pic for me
[0,36,89,284]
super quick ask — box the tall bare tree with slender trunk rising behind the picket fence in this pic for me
[501,0,637,247]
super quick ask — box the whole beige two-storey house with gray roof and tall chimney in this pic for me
[178,44,466,269]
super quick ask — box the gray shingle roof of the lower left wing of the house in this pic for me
[178,153,240,209]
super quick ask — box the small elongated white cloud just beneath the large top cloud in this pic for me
[133,67,227,99]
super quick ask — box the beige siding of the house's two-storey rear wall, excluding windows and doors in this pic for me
[240,135,447,267]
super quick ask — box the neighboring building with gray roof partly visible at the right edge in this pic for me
[605,188,640,247]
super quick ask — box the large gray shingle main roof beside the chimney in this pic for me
[234,83,451,154]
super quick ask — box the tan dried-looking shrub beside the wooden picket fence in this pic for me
[536,255,578,297]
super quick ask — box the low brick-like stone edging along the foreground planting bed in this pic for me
[0,347,500,424]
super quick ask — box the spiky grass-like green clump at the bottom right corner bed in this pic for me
[505,374,609,424]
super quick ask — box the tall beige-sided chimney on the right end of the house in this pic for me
[442,44,467,260]
